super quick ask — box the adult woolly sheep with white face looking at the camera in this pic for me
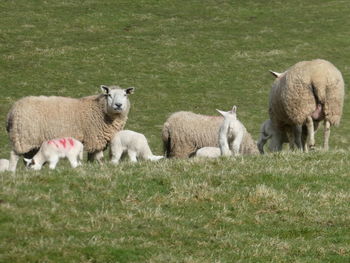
[6,85,134,172]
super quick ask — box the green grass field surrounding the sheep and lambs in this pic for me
[0,0,350,263]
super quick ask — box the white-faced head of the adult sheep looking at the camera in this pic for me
[101,85,135,115]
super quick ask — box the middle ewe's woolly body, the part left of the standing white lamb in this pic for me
[162,111,223,158]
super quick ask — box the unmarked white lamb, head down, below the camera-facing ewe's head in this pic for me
[110,130,163,164]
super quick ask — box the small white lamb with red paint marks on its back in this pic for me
[24,137,84,170]
